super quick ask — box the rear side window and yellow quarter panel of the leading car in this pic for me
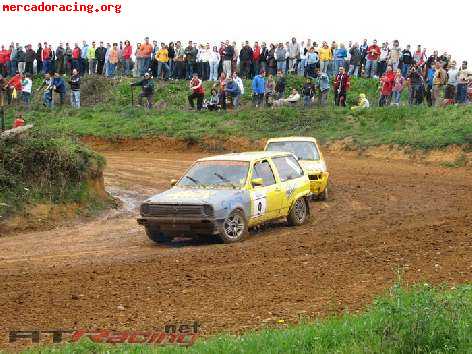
[272,155,304,216]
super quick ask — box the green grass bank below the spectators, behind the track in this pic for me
[3,76,472,149]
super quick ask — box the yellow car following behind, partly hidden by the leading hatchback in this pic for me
[265,137,329,200]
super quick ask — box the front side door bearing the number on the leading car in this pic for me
[251,160,284,223]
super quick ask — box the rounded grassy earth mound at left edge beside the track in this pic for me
[0,131,109,229]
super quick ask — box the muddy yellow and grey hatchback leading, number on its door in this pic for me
[138,151,311,243]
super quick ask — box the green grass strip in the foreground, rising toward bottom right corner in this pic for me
[26,284,472,354]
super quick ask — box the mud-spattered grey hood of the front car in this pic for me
[145,187,242,205]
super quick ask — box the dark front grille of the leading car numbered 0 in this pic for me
[141,204,213,217]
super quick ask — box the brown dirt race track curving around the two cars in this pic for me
[0,152,472,347]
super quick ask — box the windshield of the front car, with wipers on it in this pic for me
[177,161,249,188]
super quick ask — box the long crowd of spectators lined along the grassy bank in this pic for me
[0,37,472,110]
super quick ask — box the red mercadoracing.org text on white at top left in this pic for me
[1,1,121,14]
